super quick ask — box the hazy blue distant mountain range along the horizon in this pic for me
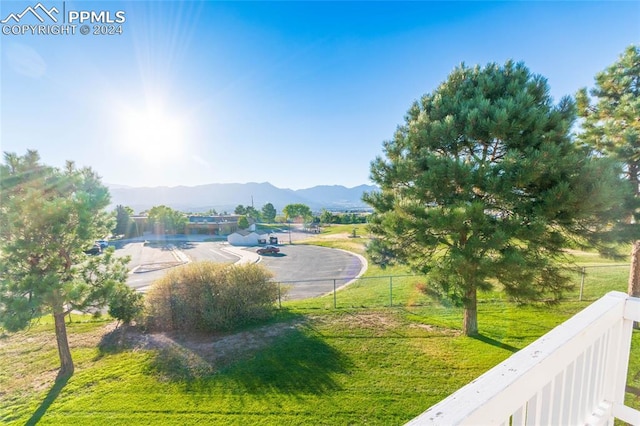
[107,182,377,213]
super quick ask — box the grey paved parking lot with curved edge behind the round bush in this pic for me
[111,241,366,299]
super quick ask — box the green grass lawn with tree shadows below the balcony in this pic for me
[0,225,640,425]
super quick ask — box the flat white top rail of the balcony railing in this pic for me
[407,292,640,426]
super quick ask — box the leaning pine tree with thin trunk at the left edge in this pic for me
[0,151,128,376]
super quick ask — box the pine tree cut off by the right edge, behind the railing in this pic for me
[576,46,640,297]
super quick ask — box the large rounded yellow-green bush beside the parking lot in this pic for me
[145,262,278,331]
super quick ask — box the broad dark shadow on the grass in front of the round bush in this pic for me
[151,327,352,395]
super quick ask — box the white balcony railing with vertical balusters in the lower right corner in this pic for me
[408,292,640,426]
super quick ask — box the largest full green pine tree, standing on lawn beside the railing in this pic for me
[364,62,632,335]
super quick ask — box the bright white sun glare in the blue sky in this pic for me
[118,100,187,164]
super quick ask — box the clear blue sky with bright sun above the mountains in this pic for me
[0,0,640,189]
